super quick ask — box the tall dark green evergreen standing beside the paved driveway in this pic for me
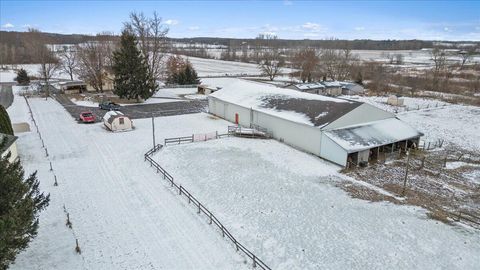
[113,30,157,100]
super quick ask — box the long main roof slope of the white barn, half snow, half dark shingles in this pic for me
[209,79,363,128]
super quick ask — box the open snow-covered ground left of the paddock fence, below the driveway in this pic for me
[8,92,250,269]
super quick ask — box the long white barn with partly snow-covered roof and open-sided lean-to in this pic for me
[208,79,423,166]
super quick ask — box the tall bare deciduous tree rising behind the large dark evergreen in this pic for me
[124,12,169,79]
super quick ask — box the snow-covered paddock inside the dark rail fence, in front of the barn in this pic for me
[154,138,480,269]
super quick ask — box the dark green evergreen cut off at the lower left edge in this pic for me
[0,149,50,269]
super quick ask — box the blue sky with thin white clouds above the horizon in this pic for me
[0,0,480,41]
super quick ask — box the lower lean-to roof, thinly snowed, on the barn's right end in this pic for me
[325,118,423,153]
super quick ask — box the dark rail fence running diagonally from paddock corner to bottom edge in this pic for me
[144,144,271,270]
